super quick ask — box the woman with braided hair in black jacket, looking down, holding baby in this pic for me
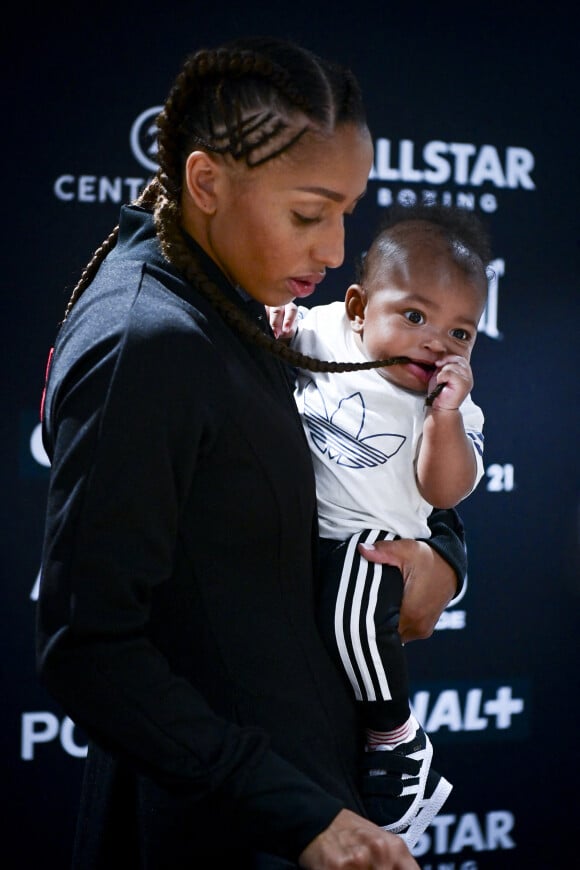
[38,38,463,870]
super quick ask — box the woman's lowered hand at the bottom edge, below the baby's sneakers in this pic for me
[298,810,419,870]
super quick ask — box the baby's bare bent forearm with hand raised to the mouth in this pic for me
[415,356,477,508]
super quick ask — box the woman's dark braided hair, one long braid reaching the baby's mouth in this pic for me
[65,37,412,372]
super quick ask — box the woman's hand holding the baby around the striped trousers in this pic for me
[359,538,457,643]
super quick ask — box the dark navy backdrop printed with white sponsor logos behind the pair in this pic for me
[0,0,580,870]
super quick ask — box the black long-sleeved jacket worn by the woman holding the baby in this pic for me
[38,207,462,870]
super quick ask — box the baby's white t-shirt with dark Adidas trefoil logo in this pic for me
[292,302,484,540]
